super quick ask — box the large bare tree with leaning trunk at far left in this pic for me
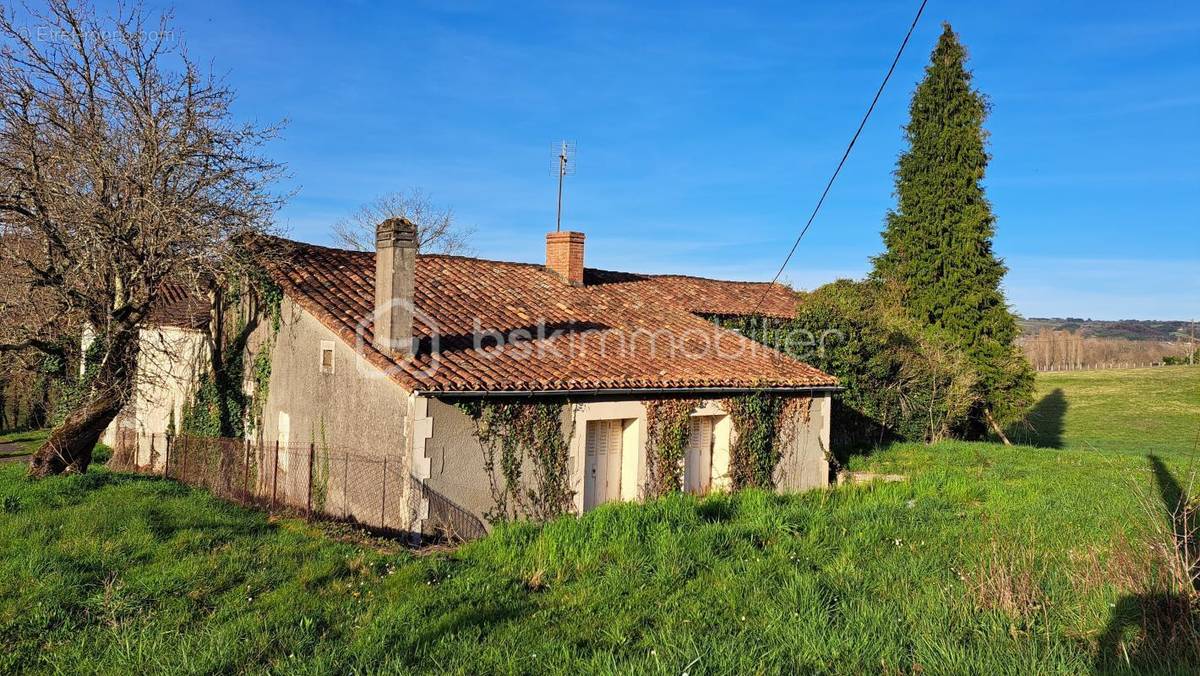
[0,0,281,475]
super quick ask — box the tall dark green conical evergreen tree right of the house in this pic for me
[874,24,1033,433]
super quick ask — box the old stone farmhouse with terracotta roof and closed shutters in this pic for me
[107,220,838,533]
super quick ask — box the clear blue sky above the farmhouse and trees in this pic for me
[131,0,1200,319]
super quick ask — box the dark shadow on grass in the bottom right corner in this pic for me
[1096,455,1200,674]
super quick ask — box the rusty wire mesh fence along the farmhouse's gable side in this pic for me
[108,431,486,540]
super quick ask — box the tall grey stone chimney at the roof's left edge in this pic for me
[373,219,416,358]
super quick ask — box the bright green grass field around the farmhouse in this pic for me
[0,367,1200,675]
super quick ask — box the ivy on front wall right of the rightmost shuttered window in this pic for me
[724,390,812,490]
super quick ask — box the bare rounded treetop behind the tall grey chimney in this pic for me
[334,189,474,255]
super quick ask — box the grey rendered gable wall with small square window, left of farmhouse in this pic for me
[246,297,415,528]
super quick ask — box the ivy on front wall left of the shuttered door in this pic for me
[458,399,575,524]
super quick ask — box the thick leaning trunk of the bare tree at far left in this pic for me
[29,328,138,477]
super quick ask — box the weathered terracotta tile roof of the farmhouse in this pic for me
[255,240,836,393]
